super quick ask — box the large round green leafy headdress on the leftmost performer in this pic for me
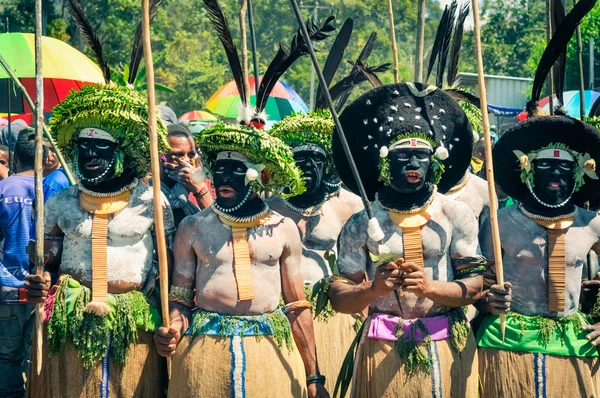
[50,85,169,178]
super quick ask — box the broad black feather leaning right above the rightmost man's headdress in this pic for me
[528,0,597,105]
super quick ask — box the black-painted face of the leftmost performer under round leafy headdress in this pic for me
[77,138,117,184]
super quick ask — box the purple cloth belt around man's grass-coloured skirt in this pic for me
[367,312,471,342]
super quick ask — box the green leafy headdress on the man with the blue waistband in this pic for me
[195,123,305,196]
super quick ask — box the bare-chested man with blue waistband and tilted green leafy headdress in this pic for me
[155,124,328,398]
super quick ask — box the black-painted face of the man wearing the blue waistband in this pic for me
[213,159,249,209]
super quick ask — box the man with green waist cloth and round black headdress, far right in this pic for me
[477,116,600,397]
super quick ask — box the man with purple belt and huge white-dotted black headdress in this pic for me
[329,83,485,397]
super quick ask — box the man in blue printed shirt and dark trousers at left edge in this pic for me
[0,128,35,397]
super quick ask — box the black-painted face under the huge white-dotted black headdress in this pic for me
[388,148,431,193]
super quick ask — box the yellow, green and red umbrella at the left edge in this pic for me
[0,33,104,114]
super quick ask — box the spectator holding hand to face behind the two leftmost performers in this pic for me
[155,124,213,225]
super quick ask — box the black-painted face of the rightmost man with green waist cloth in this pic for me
[533,159,575,205]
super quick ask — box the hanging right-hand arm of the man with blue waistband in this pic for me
[280,219,334,396]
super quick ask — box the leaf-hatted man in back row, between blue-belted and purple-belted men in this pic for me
[267,110,363,391]
